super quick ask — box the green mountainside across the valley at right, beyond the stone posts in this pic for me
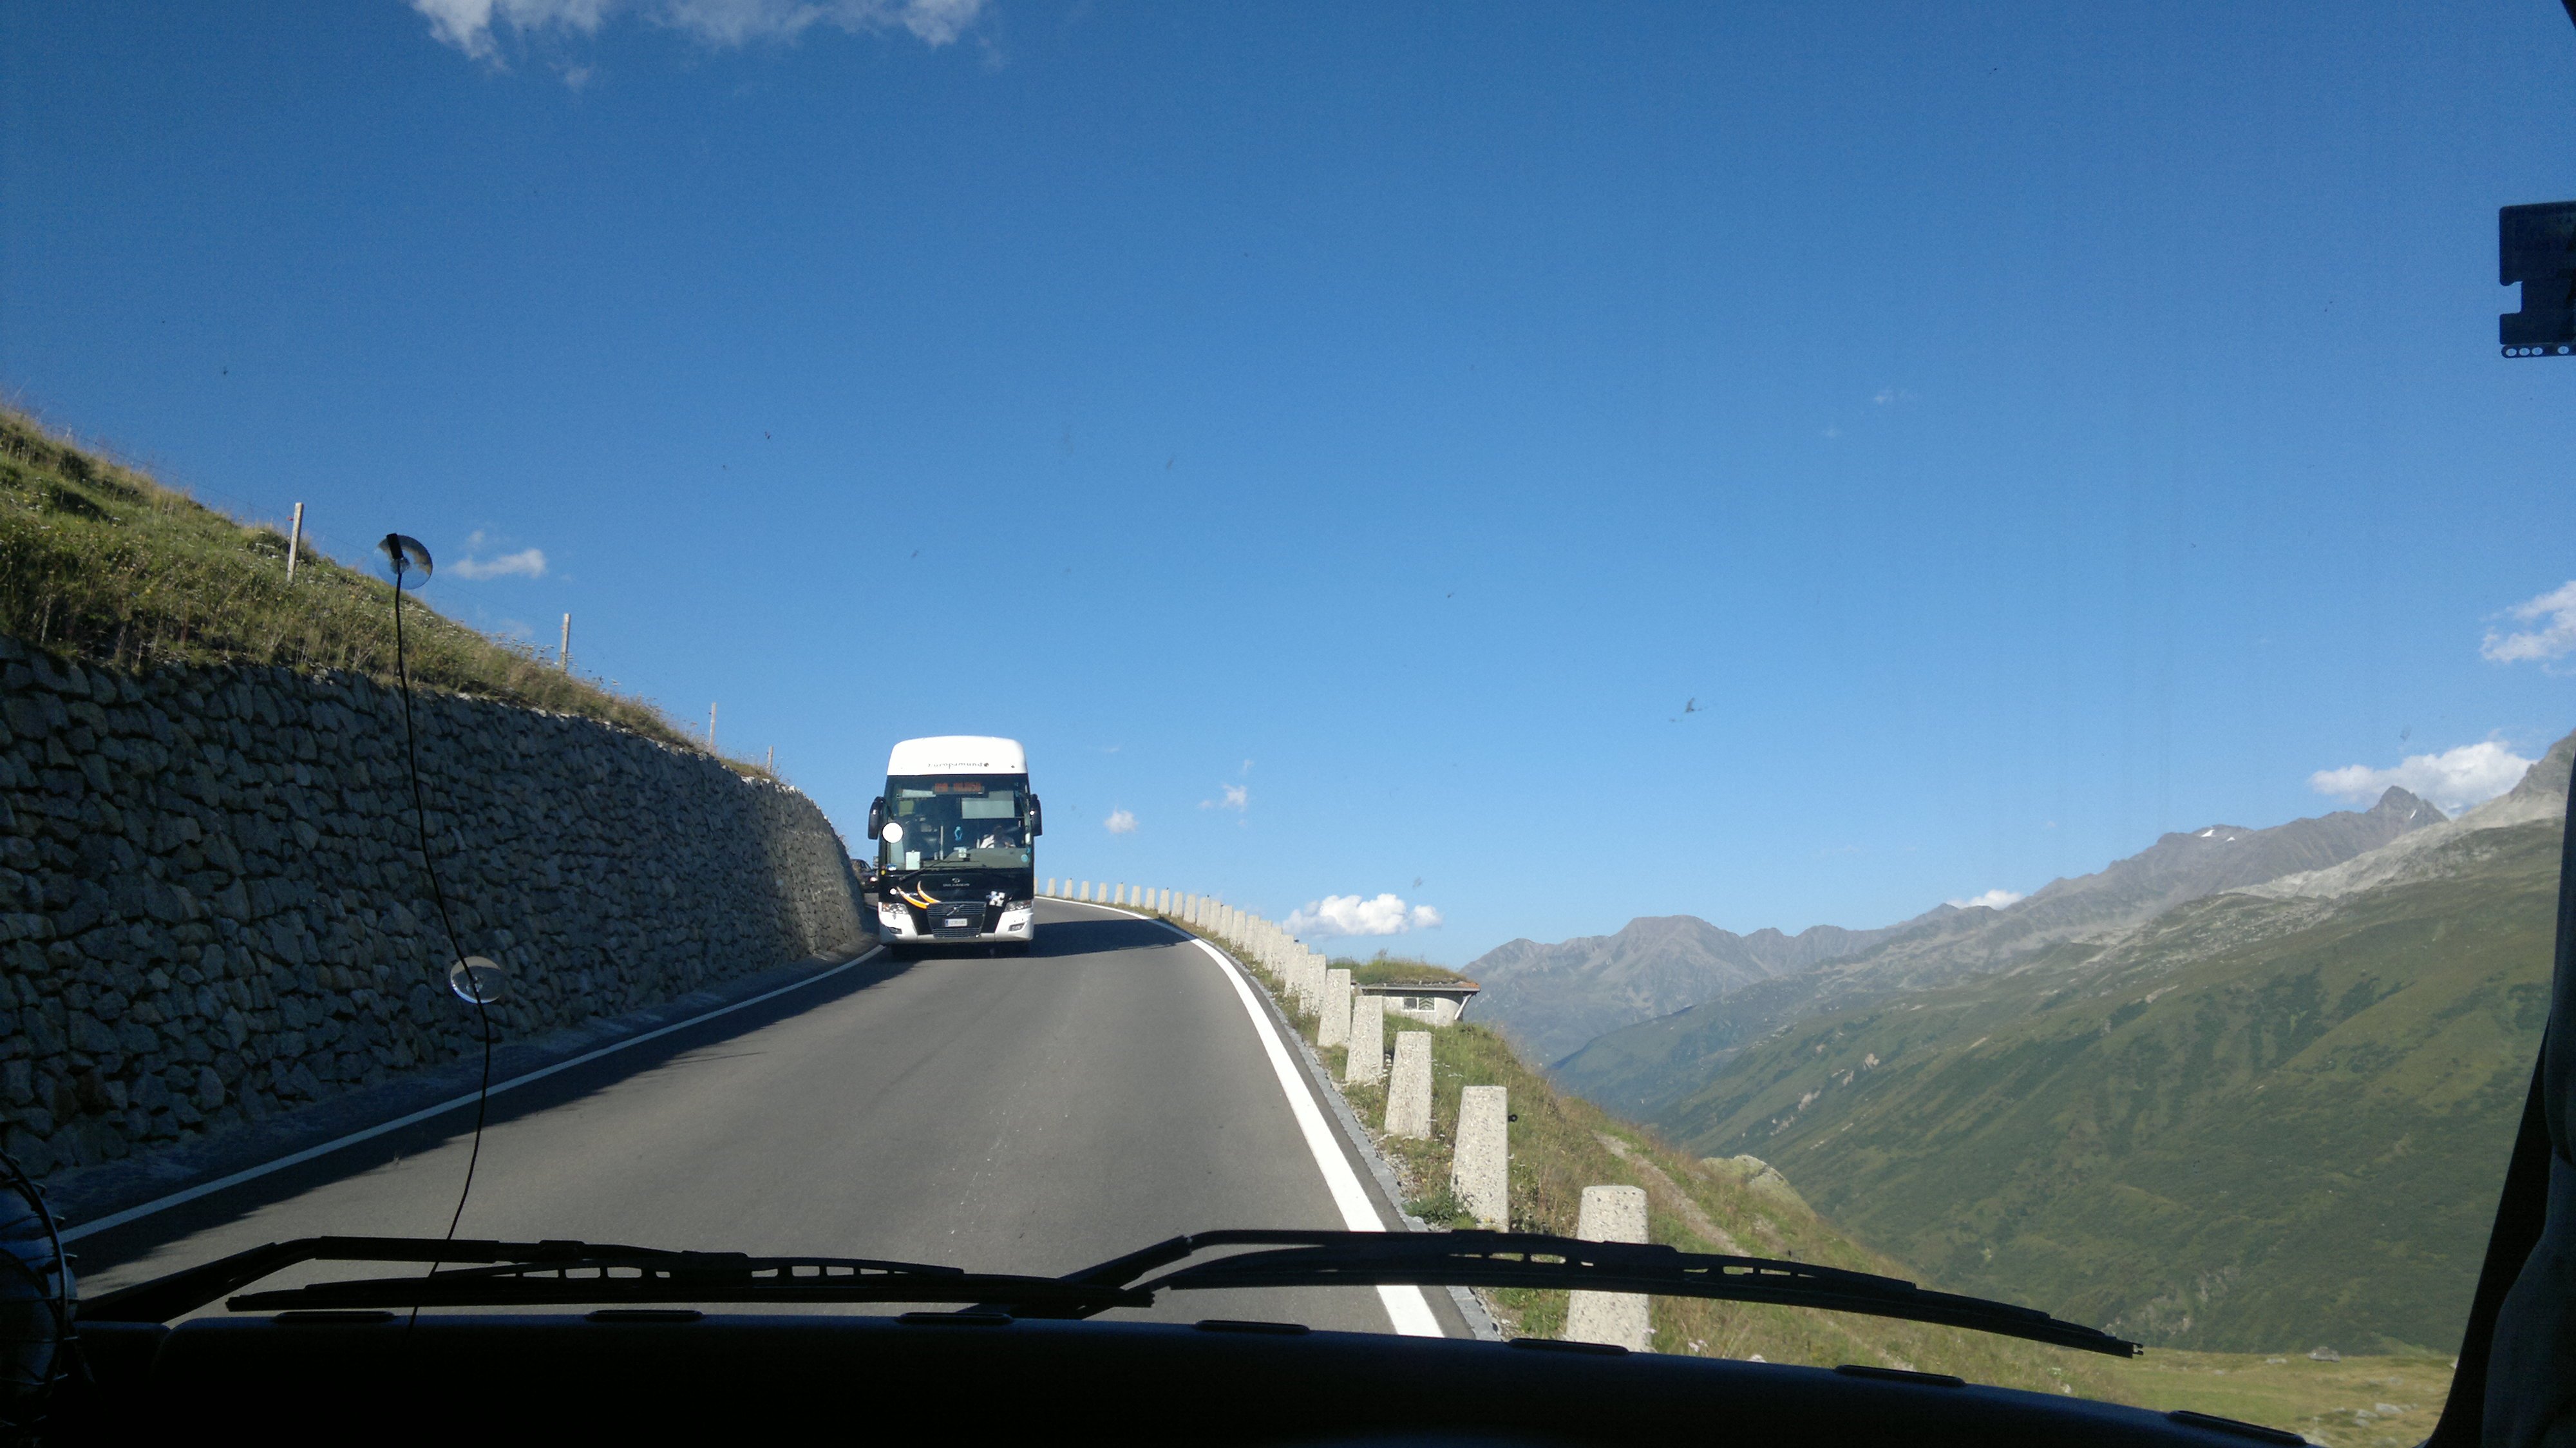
[1656,819,2561,1353]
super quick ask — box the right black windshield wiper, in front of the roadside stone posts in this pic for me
[1036,1232,2141,1358]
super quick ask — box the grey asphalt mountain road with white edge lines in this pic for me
[75,902,1463,1332]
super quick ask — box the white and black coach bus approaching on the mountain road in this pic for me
[868,734,1043,956]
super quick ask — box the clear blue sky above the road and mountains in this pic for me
[0,0,2576,961]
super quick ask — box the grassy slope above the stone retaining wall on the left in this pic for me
[0,410,747,768]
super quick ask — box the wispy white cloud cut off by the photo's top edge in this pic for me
[412,0,984,60]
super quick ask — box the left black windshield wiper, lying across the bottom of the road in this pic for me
[80,1237,1154,1322]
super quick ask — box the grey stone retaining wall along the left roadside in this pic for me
[0,636,860,1175]
